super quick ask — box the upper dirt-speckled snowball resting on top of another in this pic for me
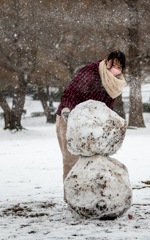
[66,100,126,156]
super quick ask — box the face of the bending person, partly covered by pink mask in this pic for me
[106,58,122,76]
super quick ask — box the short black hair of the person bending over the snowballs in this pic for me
[107,50,126,70]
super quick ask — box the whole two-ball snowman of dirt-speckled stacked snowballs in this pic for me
[64,100,132,219]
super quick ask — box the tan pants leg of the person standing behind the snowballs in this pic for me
[56,115,79,180]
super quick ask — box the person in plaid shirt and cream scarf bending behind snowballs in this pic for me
[56,50,126,186]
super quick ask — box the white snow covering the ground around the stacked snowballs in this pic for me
[0,96,150,240]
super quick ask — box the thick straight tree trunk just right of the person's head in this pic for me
[125,0,145,127]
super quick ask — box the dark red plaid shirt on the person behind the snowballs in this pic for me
[56,61,114,115]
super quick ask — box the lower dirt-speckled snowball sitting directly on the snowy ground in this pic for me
[64,155,132,219]
